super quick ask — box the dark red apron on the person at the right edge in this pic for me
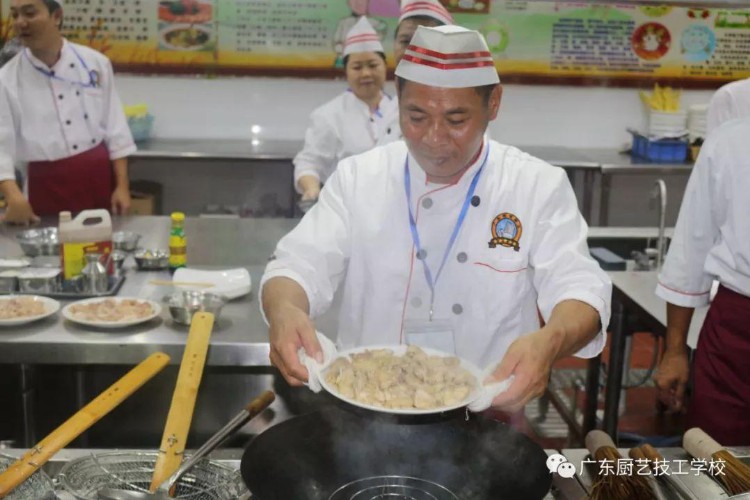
[688,286,750,446]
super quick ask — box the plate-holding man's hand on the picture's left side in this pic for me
[268,304,323,387]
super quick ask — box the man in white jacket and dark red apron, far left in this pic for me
[0,0,136,223]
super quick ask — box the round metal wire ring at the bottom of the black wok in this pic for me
[329,476,458,500]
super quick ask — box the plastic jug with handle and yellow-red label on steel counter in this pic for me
[58,209,112,280]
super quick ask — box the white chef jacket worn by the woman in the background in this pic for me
[294,90,401,191]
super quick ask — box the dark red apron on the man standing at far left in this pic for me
[28,143,114,215]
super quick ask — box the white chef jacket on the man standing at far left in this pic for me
[0,40,136,180]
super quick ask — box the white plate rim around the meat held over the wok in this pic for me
[319,344,482,415]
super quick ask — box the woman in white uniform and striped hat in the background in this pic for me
[294,17,400,201]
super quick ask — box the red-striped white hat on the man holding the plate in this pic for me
[396,25,500,88]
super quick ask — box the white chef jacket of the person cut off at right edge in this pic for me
[656,117,750,307]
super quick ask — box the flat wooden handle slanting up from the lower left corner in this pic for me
[0,352,169,498]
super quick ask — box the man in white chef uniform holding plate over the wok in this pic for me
[261,26,611,413]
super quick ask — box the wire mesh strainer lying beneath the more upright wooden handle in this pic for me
[59,452,247,500]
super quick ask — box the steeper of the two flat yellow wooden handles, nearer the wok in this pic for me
[149,312,214,493]
